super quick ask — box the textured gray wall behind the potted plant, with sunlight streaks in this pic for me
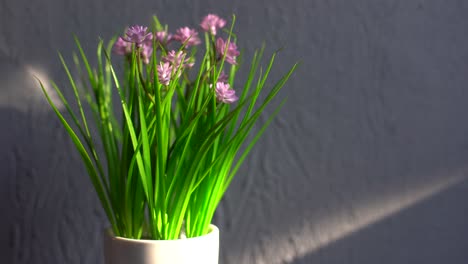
[0,0,468,264]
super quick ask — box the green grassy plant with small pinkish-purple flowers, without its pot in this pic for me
[39,14,297,240]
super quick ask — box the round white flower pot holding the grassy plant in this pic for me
[104,225,219,264]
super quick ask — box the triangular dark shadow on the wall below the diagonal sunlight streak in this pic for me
[287,171,468,264]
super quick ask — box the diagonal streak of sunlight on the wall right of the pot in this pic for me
[265,168,467,263]
